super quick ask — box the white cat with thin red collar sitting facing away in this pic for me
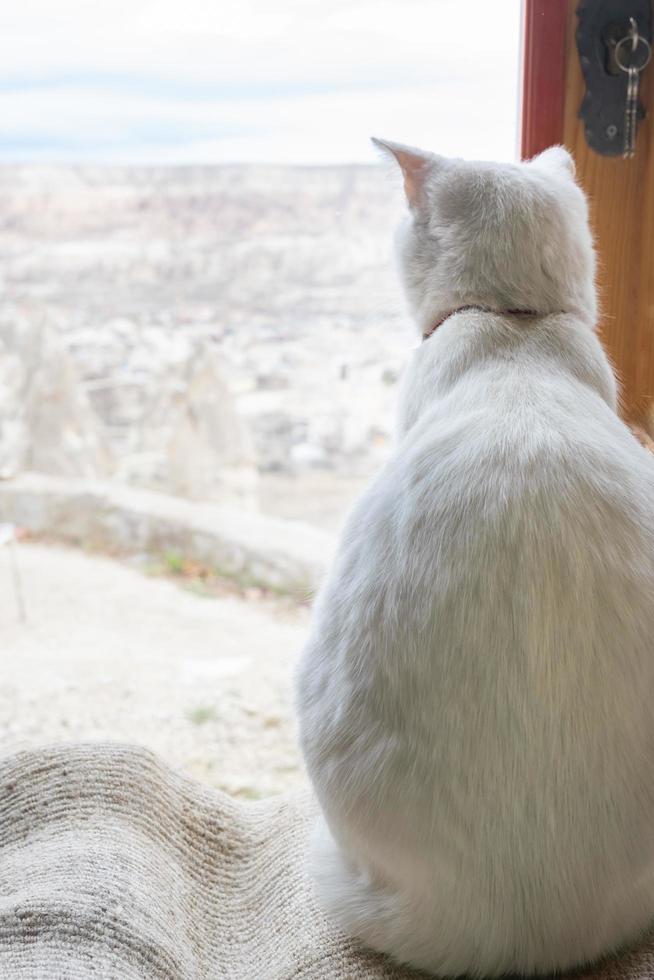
[298,142,654,976]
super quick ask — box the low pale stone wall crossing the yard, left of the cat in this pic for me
[0,474,334,600]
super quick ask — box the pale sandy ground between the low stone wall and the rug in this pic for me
[0,543,308,798]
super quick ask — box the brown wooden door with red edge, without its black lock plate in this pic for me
[520,0,654,434]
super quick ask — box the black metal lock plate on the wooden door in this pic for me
[576,0,652,156]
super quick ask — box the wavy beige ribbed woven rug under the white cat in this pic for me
[0,745,654,980]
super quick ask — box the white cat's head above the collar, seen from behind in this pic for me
[373,139,597,333]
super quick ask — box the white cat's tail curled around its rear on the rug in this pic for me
[311,818,636,978]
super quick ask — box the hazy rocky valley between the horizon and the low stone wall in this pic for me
[0,165,413,528]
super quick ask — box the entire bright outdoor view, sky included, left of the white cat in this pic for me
[0,0,520,798]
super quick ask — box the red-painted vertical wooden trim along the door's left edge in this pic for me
[520,0,568,159]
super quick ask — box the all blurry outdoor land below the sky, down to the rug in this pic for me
[0,165,415,798]
